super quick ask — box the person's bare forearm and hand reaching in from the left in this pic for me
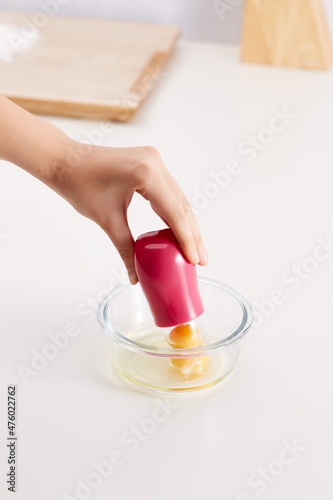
[0,96,207,283]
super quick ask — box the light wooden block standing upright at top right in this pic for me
[241,0,333,70]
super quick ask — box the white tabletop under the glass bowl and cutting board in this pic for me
[0,41,333,500]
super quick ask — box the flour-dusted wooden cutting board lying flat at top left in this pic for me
[0,12,180,122]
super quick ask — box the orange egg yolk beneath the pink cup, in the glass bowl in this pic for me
[168,324,210,378]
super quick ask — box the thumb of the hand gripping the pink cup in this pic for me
[104,210,138,285]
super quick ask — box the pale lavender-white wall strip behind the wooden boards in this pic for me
[0,0,333,42]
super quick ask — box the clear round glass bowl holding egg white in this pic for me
[98,278,252,392]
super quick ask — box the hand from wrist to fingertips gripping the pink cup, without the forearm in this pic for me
[54,140,208,284]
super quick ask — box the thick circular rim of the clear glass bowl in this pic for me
[97,276,253,358]
